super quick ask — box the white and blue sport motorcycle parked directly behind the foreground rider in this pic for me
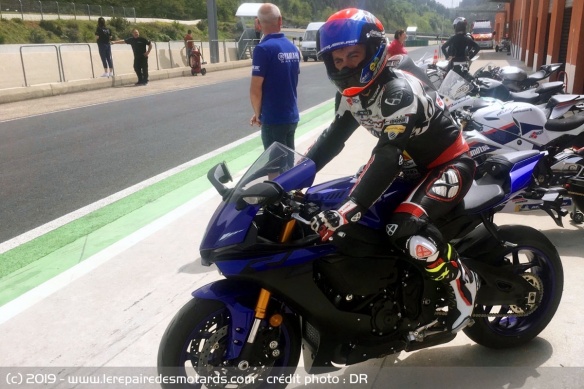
[438,72,584,225]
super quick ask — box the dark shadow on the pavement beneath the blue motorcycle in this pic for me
[300,338,560,389]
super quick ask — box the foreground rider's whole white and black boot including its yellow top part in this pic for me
[426,244,479,332]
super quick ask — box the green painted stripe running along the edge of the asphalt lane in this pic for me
[0,101,333,306]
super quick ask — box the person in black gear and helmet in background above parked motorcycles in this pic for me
[442,16,481,76]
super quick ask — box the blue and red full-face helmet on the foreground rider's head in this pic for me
[316,8,388,97]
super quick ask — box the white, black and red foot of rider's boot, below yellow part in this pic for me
[446,261,479,332]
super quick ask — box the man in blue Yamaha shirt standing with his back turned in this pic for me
[249,3,301,149]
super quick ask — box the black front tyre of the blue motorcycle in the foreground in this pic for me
[158,297,302,389]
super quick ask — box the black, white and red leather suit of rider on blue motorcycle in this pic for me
[307,68,475,260]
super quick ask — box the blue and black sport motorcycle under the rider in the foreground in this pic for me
[158,143,563,388]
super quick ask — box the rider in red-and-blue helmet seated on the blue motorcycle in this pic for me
[307,8,477,331]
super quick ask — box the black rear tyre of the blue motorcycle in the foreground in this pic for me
[464,225,564,349]
